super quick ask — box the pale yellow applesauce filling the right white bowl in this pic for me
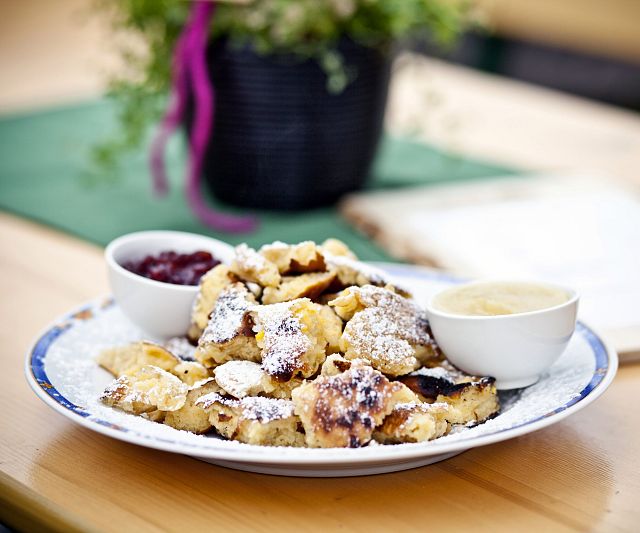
[431,282,570,316]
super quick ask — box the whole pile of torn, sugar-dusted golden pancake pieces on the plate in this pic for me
[98,239,500,448]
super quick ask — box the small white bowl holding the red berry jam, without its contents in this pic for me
[104,231,233,338]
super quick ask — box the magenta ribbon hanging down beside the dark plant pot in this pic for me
[149,1,257,233]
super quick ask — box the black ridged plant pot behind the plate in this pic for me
[198,39,390,209]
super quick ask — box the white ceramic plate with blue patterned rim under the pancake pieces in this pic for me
[25,264,618,476]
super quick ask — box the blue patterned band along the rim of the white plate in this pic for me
[25,263,617,460]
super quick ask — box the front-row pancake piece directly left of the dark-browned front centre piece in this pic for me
[196,393,304,446]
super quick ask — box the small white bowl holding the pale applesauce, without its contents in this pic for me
[427,281,579,389]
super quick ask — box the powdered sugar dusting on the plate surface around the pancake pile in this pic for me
[45,296,595,459]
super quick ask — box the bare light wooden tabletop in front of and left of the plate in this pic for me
[0,210,640,531]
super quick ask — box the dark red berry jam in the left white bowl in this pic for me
[122,250,220,285]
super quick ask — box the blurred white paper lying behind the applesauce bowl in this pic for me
[408,191,640,328]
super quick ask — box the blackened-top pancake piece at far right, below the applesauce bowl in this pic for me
[400,366,500,425]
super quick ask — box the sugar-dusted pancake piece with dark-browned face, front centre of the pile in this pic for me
[292,361,416,448]
